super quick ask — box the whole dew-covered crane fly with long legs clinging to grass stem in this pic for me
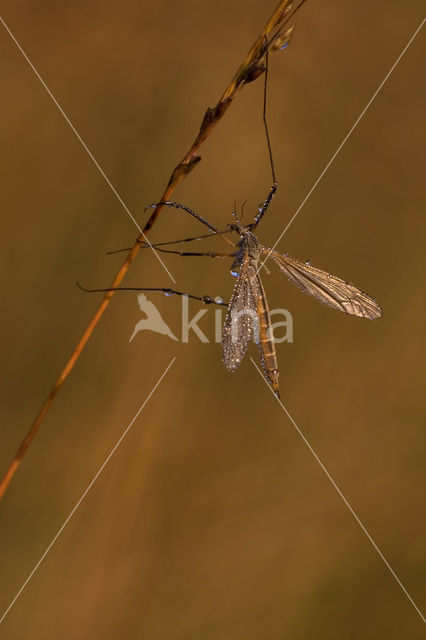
[86,33,382,396]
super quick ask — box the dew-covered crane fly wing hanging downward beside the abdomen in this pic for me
[222,252,259,371]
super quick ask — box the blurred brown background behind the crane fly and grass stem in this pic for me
[0,0,426,640]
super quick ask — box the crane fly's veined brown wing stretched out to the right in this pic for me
[268,247,383,320]
